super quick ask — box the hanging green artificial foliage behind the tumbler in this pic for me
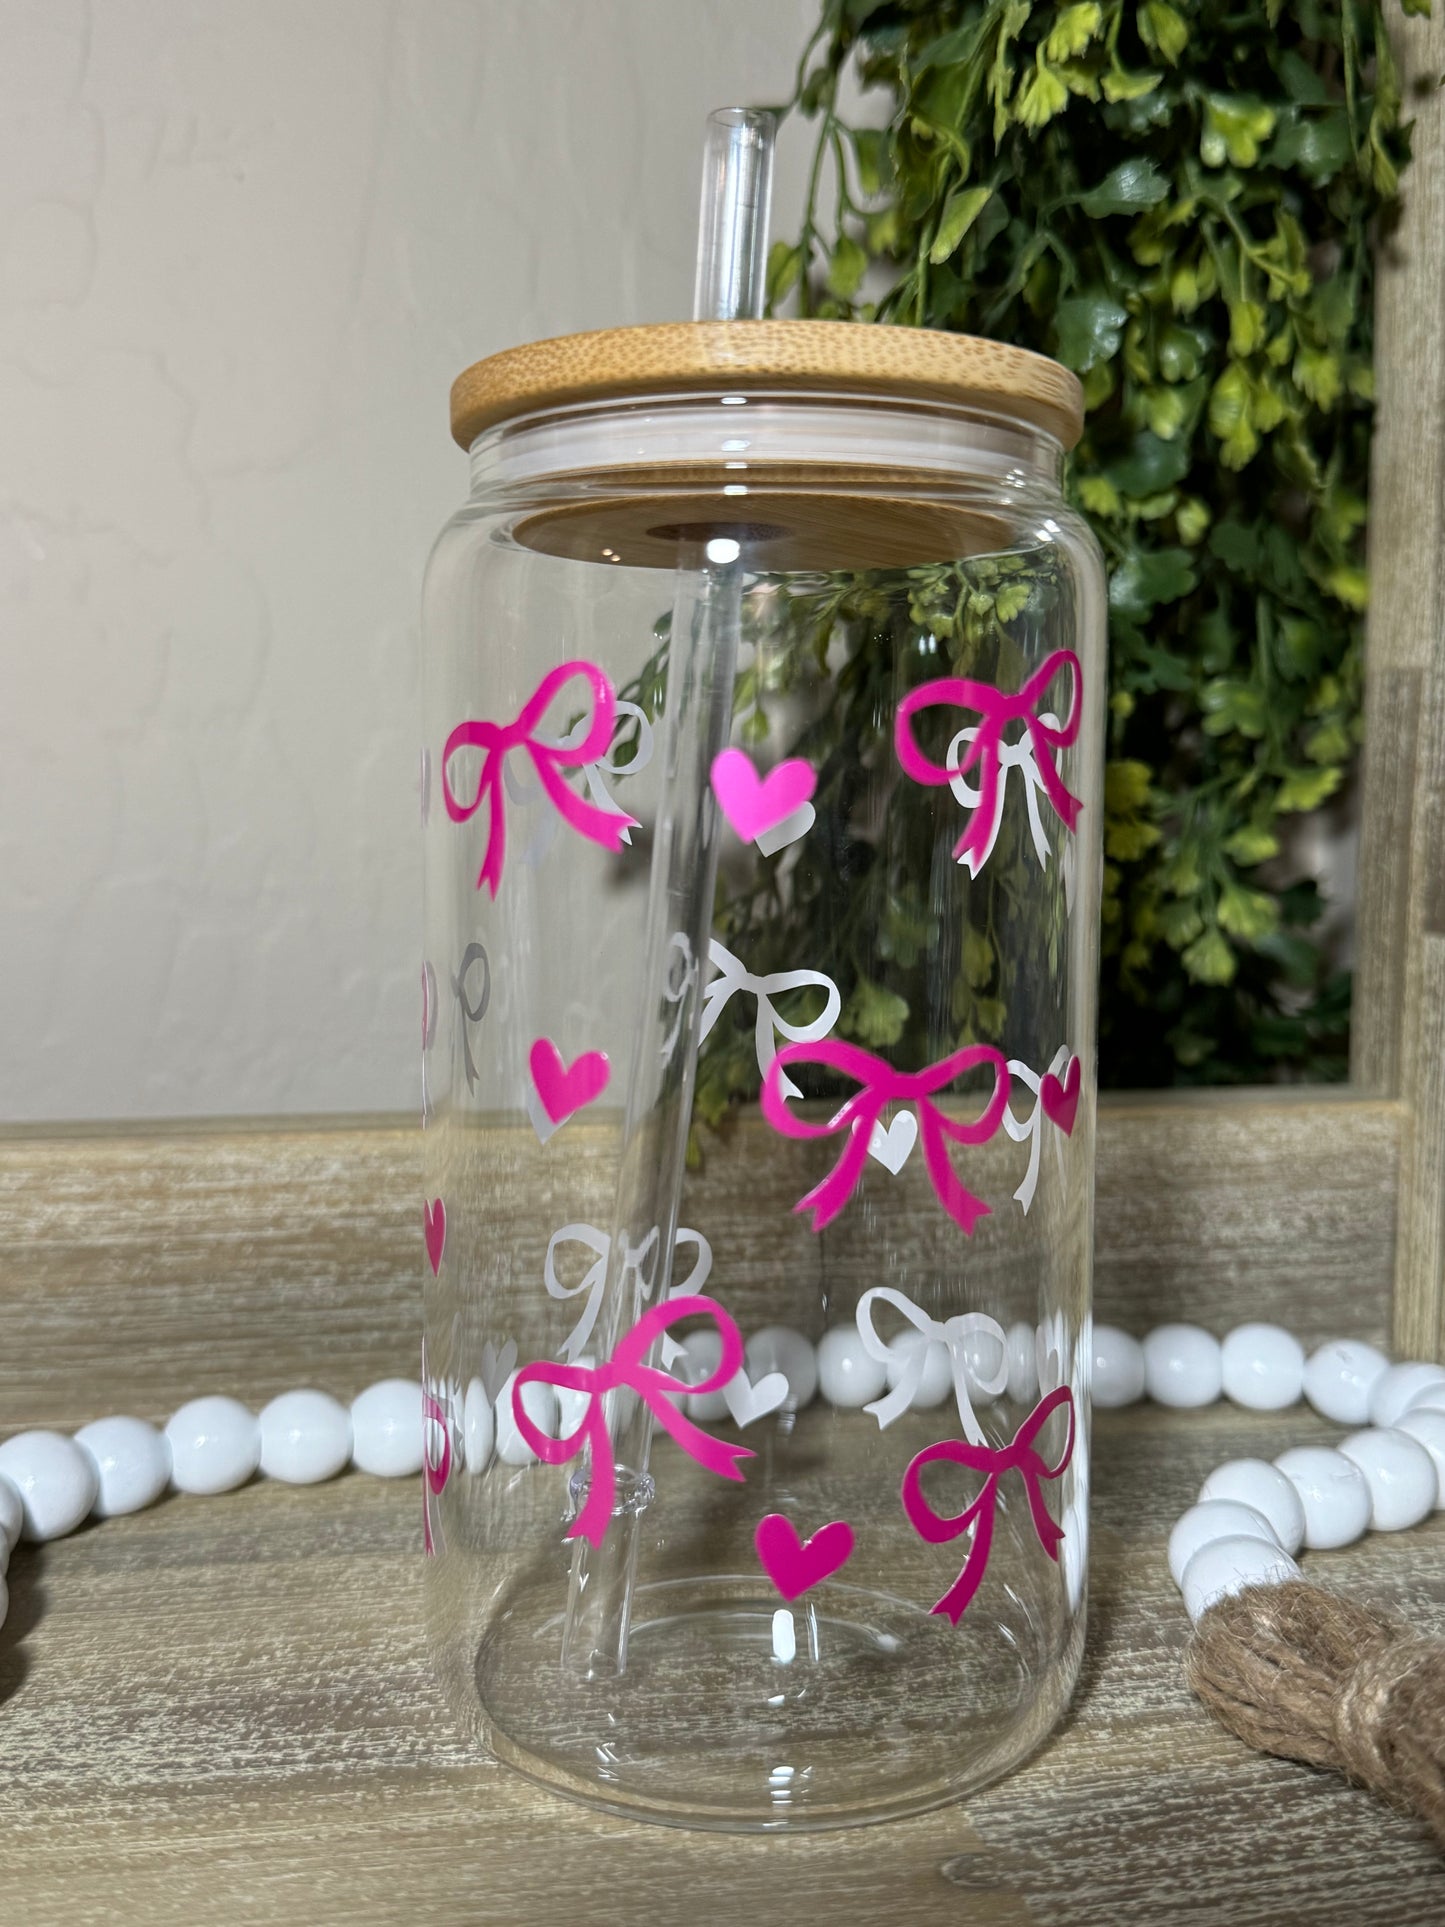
[747,0,1426,1086]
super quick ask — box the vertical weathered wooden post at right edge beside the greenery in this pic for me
[1353,8,1445,1357]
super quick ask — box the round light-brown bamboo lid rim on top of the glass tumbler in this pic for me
[451,322,1083,449]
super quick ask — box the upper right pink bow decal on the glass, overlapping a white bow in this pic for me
[894,649,1083,877]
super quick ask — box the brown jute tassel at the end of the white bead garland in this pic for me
[1185,1580,1445,1852]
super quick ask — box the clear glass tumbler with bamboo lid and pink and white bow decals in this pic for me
[422,322,1104,1829]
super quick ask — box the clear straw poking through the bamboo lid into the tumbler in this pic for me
[563,108,776,1678]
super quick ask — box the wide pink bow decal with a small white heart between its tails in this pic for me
[761,1037,1008,1231]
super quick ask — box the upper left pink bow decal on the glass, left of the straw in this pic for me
[441,663,638,896]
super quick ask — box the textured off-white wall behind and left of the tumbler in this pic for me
[0,0,817,1120]
